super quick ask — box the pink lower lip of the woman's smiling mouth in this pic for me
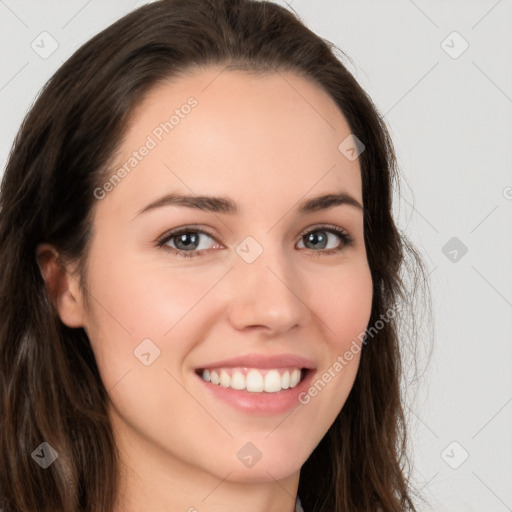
[196,370,316,415]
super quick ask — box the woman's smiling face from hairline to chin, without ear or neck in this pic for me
[70,67,372,482]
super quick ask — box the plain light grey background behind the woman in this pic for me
[0,0,512,512]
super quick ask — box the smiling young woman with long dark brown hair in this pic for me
[0,0,428,512]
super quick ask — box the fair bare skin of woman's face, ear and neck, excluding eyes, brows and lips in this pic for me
[38,67,372,512]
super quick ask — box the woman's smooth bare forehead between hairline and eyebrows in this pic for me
[98,67,361,216]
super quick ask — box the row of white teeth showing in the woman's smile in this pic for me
[202,368,301,393]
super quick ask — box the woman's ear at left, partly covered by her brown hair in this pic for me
[36,243,84,327]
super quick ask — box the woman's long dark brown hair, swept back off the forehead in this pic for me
[0,0,432,512]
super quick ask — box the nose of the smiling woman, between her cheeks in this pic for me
[228,244,311,336]
